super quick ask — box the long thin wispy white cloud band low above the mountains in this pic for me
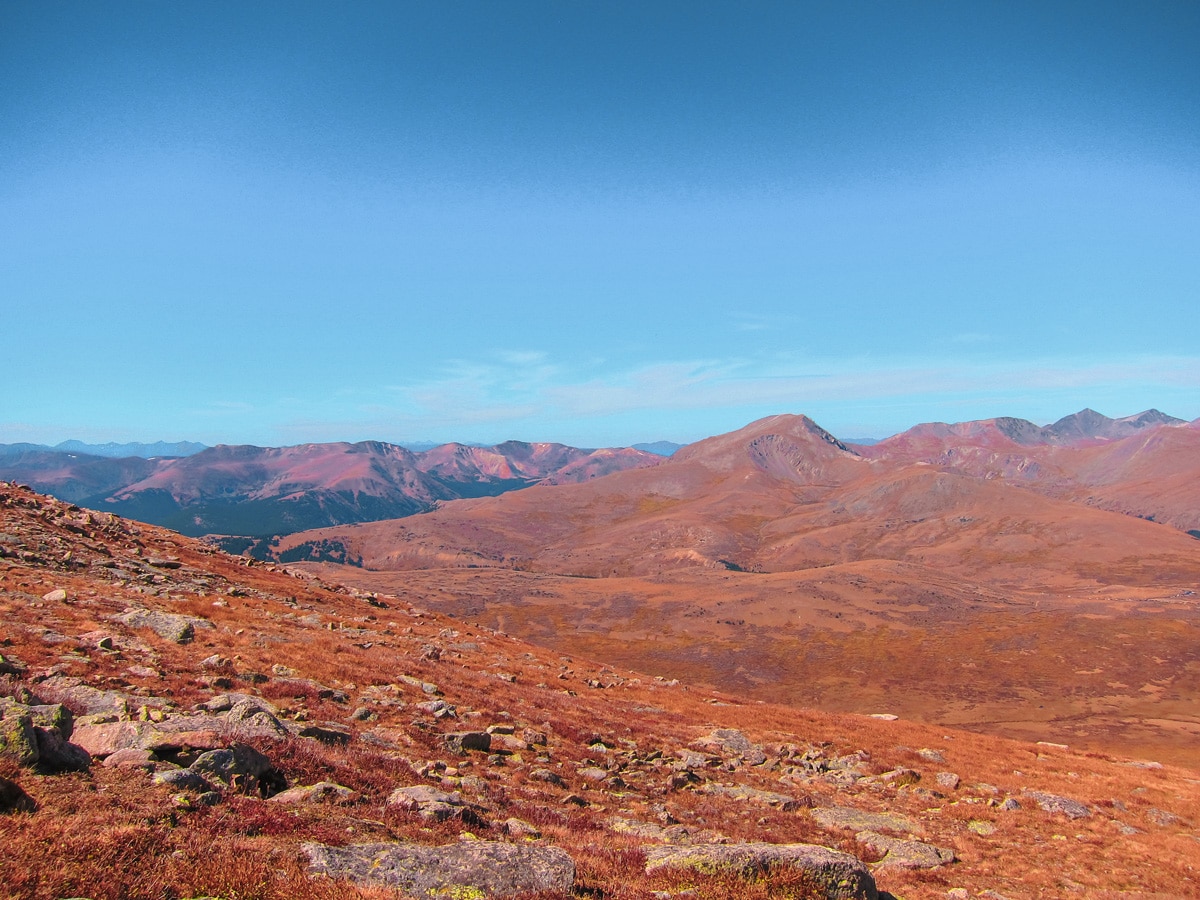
[374,356,1200,432]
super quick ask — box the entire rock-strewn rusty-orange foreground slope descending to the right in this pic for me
[7,484,1200,900]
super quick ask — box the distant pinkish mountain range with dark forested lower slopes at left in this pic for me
[0,440,661,540]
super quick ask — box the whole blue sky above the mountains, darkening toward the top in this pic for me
[0,0,1200,446]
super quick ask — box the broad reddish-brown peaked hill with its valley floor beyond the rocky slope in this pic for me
[278,416,1200,758]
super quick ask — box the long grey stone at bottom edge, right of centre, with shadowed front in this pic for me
[646,844,878,900]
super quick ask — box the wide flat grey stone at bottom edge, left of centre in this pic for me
[301,841,575,899]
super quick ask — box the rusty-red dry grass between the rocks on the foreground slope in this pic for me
[0,489,1200,900]
